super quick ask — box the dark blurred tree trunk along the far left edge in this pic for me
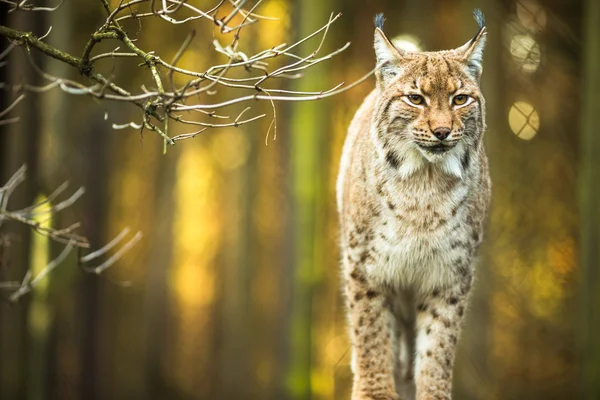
[0,7,45,400]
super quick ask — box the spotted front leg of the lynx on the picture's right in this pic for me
[415,274,472,400]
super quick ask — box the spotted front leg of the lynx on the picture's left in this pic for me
[344,253,398,400]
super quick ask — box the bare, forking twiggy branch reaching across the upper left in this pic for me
[0,0,373,151]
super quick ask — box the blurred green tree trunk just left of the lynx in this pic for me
[286,0,335,400]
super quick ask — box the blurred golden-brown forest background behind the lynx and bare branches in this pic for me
[0,0,600,400]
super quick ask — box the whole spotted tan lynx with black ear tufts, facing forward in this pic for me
[337,10,491,400]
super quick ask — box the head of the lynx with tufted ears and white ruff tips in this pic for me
[372,10,486,177]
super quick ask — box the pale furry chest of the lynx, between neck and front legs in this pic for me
[367,177,471,290]
